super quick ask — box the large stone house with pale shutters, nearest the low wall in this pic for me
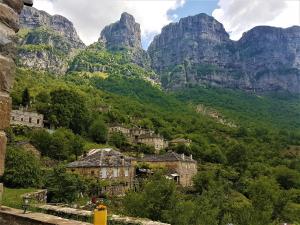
[67,148,135,195]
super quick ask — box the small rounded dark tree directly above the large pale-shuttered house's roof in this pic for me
[89,118,108,144]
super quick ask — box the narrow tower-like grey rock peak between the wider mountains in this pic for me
[100,12,142,49]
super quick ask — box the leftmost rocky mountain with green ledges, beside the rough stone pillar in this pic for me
[18,7,85,74]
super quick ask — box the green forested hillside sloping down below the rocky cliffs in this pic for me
[7,65,300,225]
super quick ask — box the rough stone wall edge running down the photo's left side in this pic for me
[0,0,32,200]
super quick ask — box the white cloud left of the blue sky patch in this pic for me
[34,0,185,44]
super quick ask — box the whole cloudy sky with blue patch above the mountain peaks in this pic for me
[34,0,300,49]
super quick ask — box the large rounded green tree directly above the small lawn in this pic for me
[3,147,43,188]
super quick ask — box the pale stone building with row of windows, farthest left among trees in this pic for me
[10,108,44,128]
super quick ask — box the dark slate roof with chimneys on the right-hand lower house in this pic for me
[138,152,196,163]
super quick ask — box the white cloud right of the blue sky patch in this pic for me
[213,0,300,40]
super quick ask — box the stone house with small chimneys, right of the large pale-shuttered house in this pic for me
[138,152,197,187]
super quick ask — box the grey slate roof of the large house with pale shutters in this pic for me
[67,148,133,168]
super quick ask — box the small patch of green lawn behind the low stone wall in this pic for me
[2,187,36,209]
